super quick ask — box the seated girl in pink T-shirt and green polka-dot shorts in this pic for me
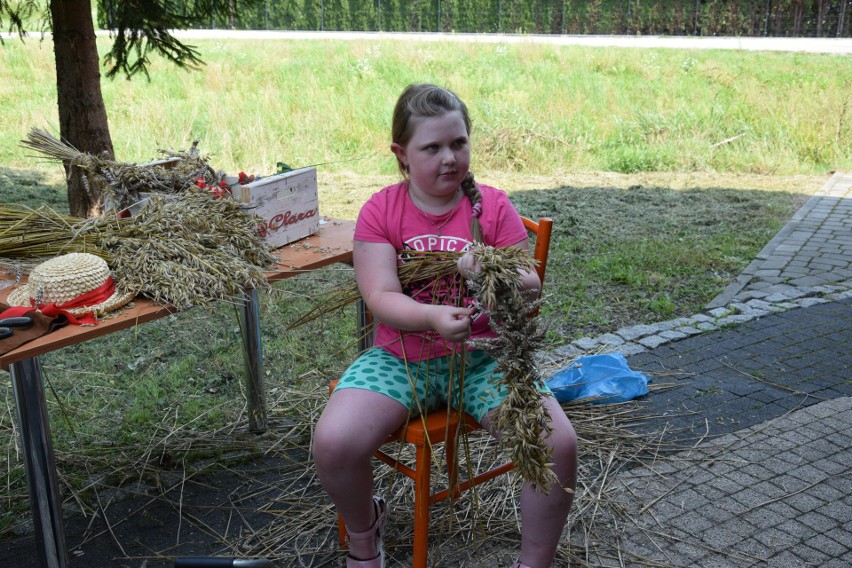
[313,85,577,568]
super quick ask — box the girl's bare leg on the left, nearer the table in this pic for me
[313,388,408,560]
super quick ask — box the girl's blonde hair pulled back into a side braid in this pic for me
[391,83,482,242]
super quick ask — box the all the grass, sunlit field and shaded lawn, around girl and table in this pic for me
[0,34,852,534]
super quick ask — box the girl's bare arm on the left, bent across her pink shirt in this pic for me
[352,241,473,342]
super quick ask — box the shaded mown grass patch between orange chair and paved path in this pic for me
[513,178,801,342]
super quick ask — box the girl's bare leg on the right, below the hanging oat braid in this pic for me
[483,396,577,568]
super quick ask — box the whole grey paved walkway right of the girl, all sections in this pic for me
[564,174,852,568]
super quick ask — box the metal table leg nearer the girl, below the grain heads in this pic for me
[240,290,267,433]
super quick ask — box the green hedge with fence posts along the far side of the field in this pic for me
[226,0,852,37]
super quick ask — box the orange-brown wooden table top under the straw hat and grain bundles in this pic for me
[0,218,355,369]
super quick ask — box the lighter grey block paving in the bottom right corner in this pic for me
[598,397,852,568]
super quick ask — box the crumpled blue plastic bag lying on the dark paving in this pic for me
[547,353,649,404]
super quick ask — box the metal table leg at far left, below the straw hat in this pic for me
[9,357,68,568]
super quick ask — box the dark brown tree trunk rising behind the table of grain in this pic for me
[50,0,114,217]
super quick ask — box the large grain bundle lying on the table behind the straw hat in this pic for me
[0,188,275,309]
